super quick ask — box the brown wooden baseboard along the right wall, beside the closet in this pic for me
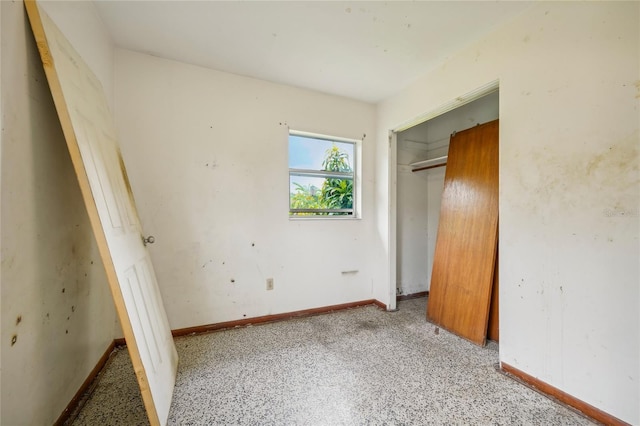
[500,362,629,426]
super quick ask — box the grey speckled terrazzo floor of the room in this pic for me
[70,298,592,425]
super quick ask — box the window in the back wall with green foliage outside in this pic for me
[289,131,357,217]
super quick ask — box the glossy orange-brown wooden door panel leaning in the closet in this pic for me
[427,120,498,345]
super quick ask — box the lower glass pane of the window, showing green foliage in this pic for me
[289,176,353,209]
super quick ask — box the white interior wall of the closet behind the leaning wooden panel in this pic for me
[396,92,498,294]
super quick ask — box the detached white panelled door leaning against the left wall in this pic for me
[25,0,178,425]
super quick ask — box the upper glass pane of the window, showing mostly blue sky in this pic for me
[289,135,354,171]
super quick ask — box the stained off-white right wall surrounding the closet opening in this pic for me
[375,2,640,424]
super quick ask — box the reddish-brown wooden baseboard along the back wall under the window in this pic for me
[171,299,387,337]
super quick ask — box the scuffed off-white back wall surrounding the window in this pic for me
[116,50,381,329]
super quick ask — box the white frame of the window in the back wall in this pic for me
[287,129,362,220]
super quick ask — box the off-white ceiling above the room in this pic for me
[96,0,531,103]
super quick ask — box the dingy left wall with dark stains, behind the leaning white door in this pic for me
[0,1,115,426]
